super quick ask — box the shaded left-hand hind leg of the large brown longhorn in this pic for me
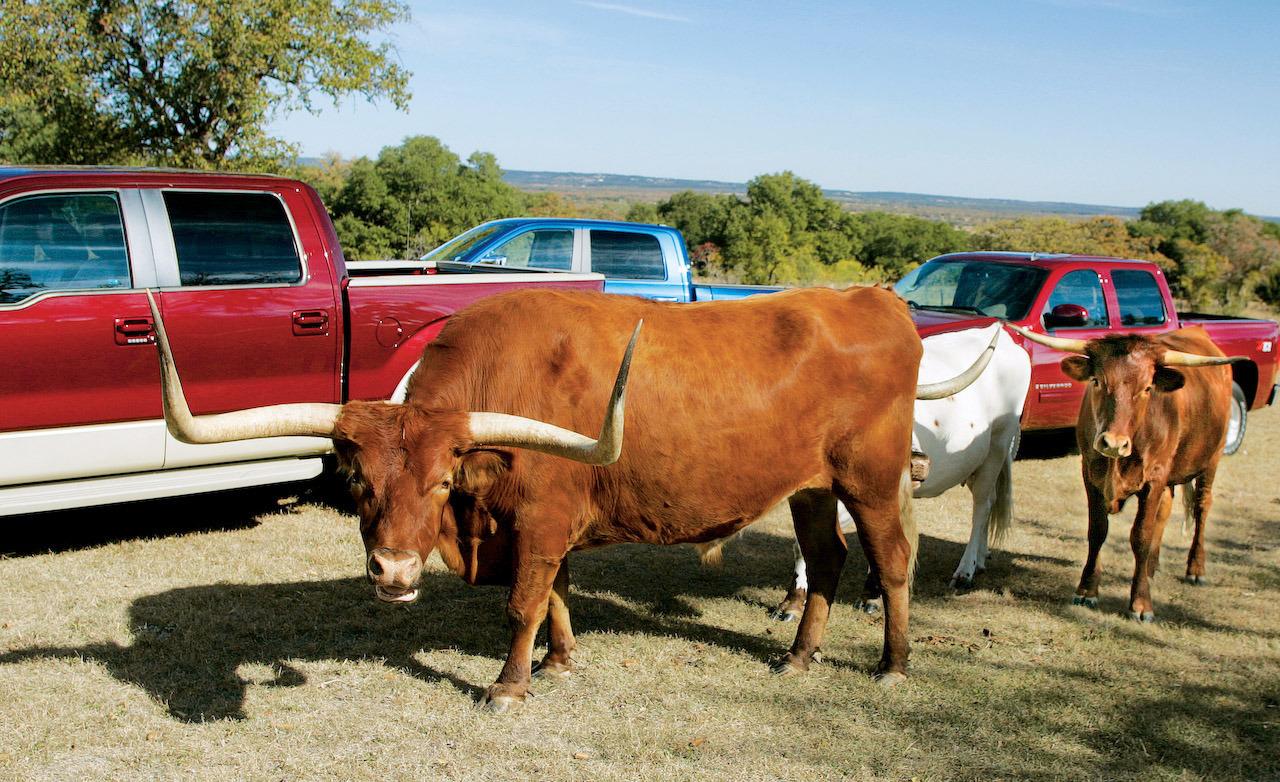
[773,489,849,674]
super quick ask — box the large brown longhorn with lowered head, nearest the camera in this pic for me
[152,288,992,712]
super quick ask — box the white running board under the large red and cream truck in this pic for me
[0,457,324,516]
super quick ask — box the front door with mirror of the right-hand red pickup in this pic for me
[1024,269,1111,429]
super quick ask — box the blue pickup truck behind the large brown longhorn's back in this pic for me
[421,218,781,302]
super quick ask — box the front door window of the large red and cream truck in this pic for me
[0,193,131,305]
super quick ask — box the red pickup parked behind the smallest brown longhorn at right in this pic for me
[895,252,1280,453]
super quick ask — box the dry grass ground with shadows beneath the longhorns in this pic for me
[0,411,1280,782]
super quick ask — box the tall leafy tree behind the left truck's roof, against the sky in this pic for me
[0,0,410,168]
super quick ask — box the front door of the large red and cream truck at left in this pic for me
[0,188,164,485]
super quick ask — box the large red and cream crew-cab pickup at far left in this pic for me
[0,168,604,516]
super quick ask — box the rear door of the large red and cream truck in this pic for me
[142,188,342,467]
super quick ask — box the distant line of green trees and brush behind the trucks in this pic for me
[298,136,1280,312]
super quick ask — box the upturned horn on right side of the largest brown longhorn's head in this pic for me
[471,320,644,467]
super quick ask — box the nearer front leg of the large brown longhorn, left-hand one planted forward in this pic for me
[485,550,568,713]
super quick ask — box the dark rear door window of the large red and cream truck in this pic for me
[164,191,302,285]
